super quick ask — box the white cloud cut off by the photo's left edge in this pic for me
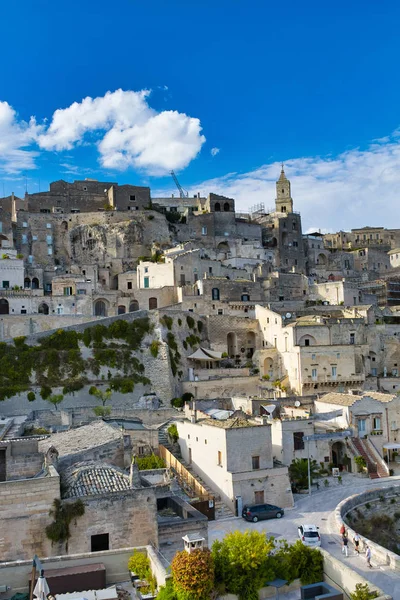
[0,102,40,173]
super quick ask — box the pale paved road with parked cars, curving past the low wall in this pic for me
[208,475,400,600]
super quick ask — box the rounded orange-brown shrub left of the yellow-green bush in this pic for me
[171,548,214,600]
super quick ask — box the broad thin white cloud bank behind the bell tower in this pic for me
[192,132,400,232]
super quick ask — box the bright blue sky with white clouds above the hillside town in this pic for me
[0,0,400,230]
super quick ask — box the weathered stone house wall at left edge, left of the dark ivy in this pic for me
[0,467,60,561]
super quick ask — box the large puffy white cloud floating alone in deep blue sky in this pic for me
[38,90,205,175]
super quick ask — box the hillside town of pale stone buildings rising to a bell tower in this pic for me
[0,165,400,600]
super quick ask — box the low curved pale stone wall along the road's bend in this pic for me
[335,484,400,571]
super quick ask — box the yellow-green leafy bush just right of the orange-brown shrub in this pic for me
[212,531,274,600]
